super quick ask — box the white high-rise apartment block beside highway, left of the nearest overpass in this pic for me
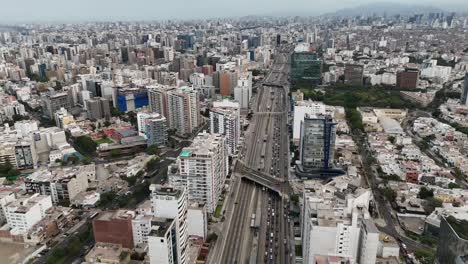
[168,132,229,213]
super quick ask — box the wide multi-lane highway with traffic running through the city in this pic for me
[217,47,294,264]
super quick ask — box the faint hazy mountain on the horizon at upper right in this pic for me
[324,2,446,17]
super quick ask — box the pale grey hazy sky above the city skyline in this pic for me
[0,0,468,23]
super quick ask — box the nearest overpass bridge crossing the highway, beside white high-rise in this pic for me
[235,161,284,196]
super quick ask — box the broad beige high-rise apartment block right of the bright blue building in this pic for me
[167,86,201,135]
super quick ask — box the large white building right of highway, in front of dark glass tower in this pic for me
[301,186,379,264]
